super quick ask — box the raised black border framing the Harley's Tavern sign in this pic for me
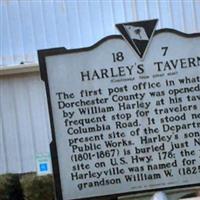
[38,28,200,200]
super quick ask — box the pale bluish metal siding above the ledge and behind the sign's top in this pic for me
[0,0,200,65]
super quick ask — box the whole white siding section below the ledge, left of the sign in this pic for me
[0,73,51,173]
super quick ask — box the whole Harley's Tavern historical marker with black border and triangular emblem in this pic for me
[38,20,200,200]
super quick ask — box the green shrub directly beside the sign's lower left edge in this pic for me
[21,174,54,200]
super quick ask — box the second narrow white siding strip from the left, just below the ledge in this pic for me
[14,76,35,172]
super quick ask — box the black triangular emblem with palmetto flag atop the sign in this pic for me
[116,19,158,59]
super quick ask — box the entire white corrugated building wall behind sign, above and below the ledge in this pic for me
[0,0,200,173]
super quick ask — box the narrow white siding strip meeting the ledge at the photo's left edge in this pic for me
[1,79,21,172]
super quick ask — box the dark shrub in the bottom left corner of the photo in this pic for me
[0,174,24,200]
